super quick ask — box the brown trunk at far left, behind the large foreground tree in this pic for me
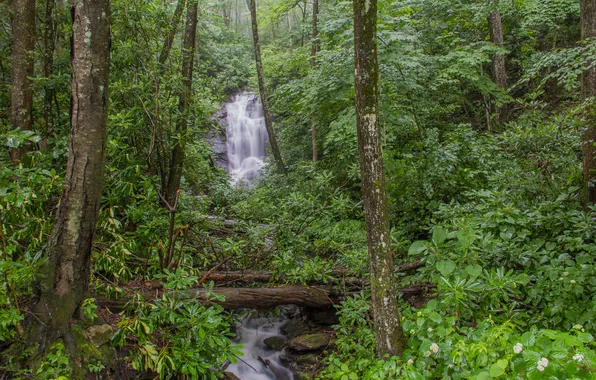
[10,0,35,162]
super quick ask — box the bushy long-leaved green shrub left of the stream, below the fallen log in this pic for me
[114,271,241,379]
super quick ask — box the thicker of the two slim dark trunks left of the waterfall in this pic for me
[167,0,198,207]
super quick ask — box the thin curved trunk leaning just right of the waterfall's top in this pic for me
[249,0,286,172]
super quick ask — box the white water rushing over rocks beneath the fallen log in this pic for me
[226,318,294,380]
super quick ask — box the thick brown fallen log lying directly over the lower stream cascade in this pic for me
[96,284,436,311]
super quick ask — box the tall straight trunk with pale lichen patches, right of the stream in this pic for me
[353,0,406,358]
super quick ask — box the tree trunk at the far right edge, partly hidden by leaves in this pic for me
[581,0,596,204]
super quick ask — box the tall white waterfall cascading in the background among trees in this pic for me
[226,92,268,185]
